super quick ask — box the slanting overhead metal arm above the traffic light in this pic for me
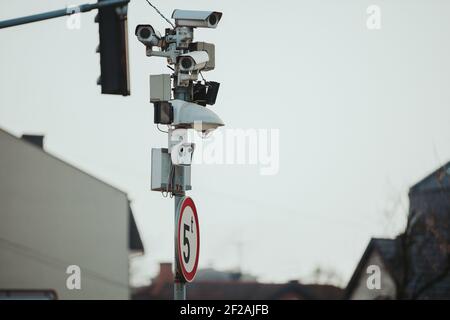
[0,0,130,29]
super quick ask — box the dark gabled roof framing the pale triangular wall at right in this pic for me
[344,237,402,299]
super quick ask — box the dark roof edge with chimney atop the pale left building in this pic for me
[0,128,144,253]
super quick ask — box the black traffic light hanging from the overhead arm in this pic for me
[95,0,130,96]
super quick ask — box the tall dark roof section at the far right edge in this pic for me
[405,162,450,299]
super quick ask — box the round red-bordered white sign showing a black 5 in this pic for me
[175,197,200,282]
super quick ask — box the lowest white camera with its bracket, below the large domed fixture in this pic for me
[169,129,195,166]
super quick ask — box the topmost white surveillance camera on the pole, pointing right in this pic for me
[172,9,222,29]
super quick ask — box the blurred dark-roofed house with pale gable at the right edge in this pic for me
[345,162,450,299]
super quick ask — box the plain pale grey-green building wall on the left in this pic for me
[0,130,129,299]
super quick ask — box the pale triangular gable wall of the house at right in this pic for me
[350,251,396,300]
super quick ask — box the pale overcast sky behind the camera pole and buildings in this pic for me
[0,0,450,284]
